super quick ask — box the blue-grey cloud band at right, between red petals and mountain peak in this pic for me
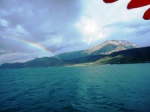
[104,19,150,47]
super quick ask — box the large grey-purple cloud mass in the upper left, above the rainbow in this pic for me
[0,0,82,51]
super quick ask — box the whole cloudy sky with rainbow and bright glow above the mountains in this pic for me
[0,0,150,64]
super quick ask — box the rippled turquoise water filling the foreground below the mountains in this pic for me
[0,64,150,112]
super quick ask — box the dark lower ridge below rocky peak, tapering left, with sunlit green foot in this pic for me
[65,47,150,65]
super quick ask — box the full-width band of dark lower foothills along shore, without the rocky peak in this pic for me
[0,47,150,69]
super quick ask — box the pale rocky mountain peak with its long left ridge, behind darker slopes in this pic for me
[55,40,138,60]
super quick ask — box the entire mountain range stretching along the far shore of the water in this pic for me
[0,40,150,69]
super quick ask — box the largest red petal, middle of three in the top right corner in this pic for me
[127,0,150,9]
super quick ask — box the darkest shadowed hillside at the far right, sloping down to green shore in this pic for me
[95,47,150,64]
